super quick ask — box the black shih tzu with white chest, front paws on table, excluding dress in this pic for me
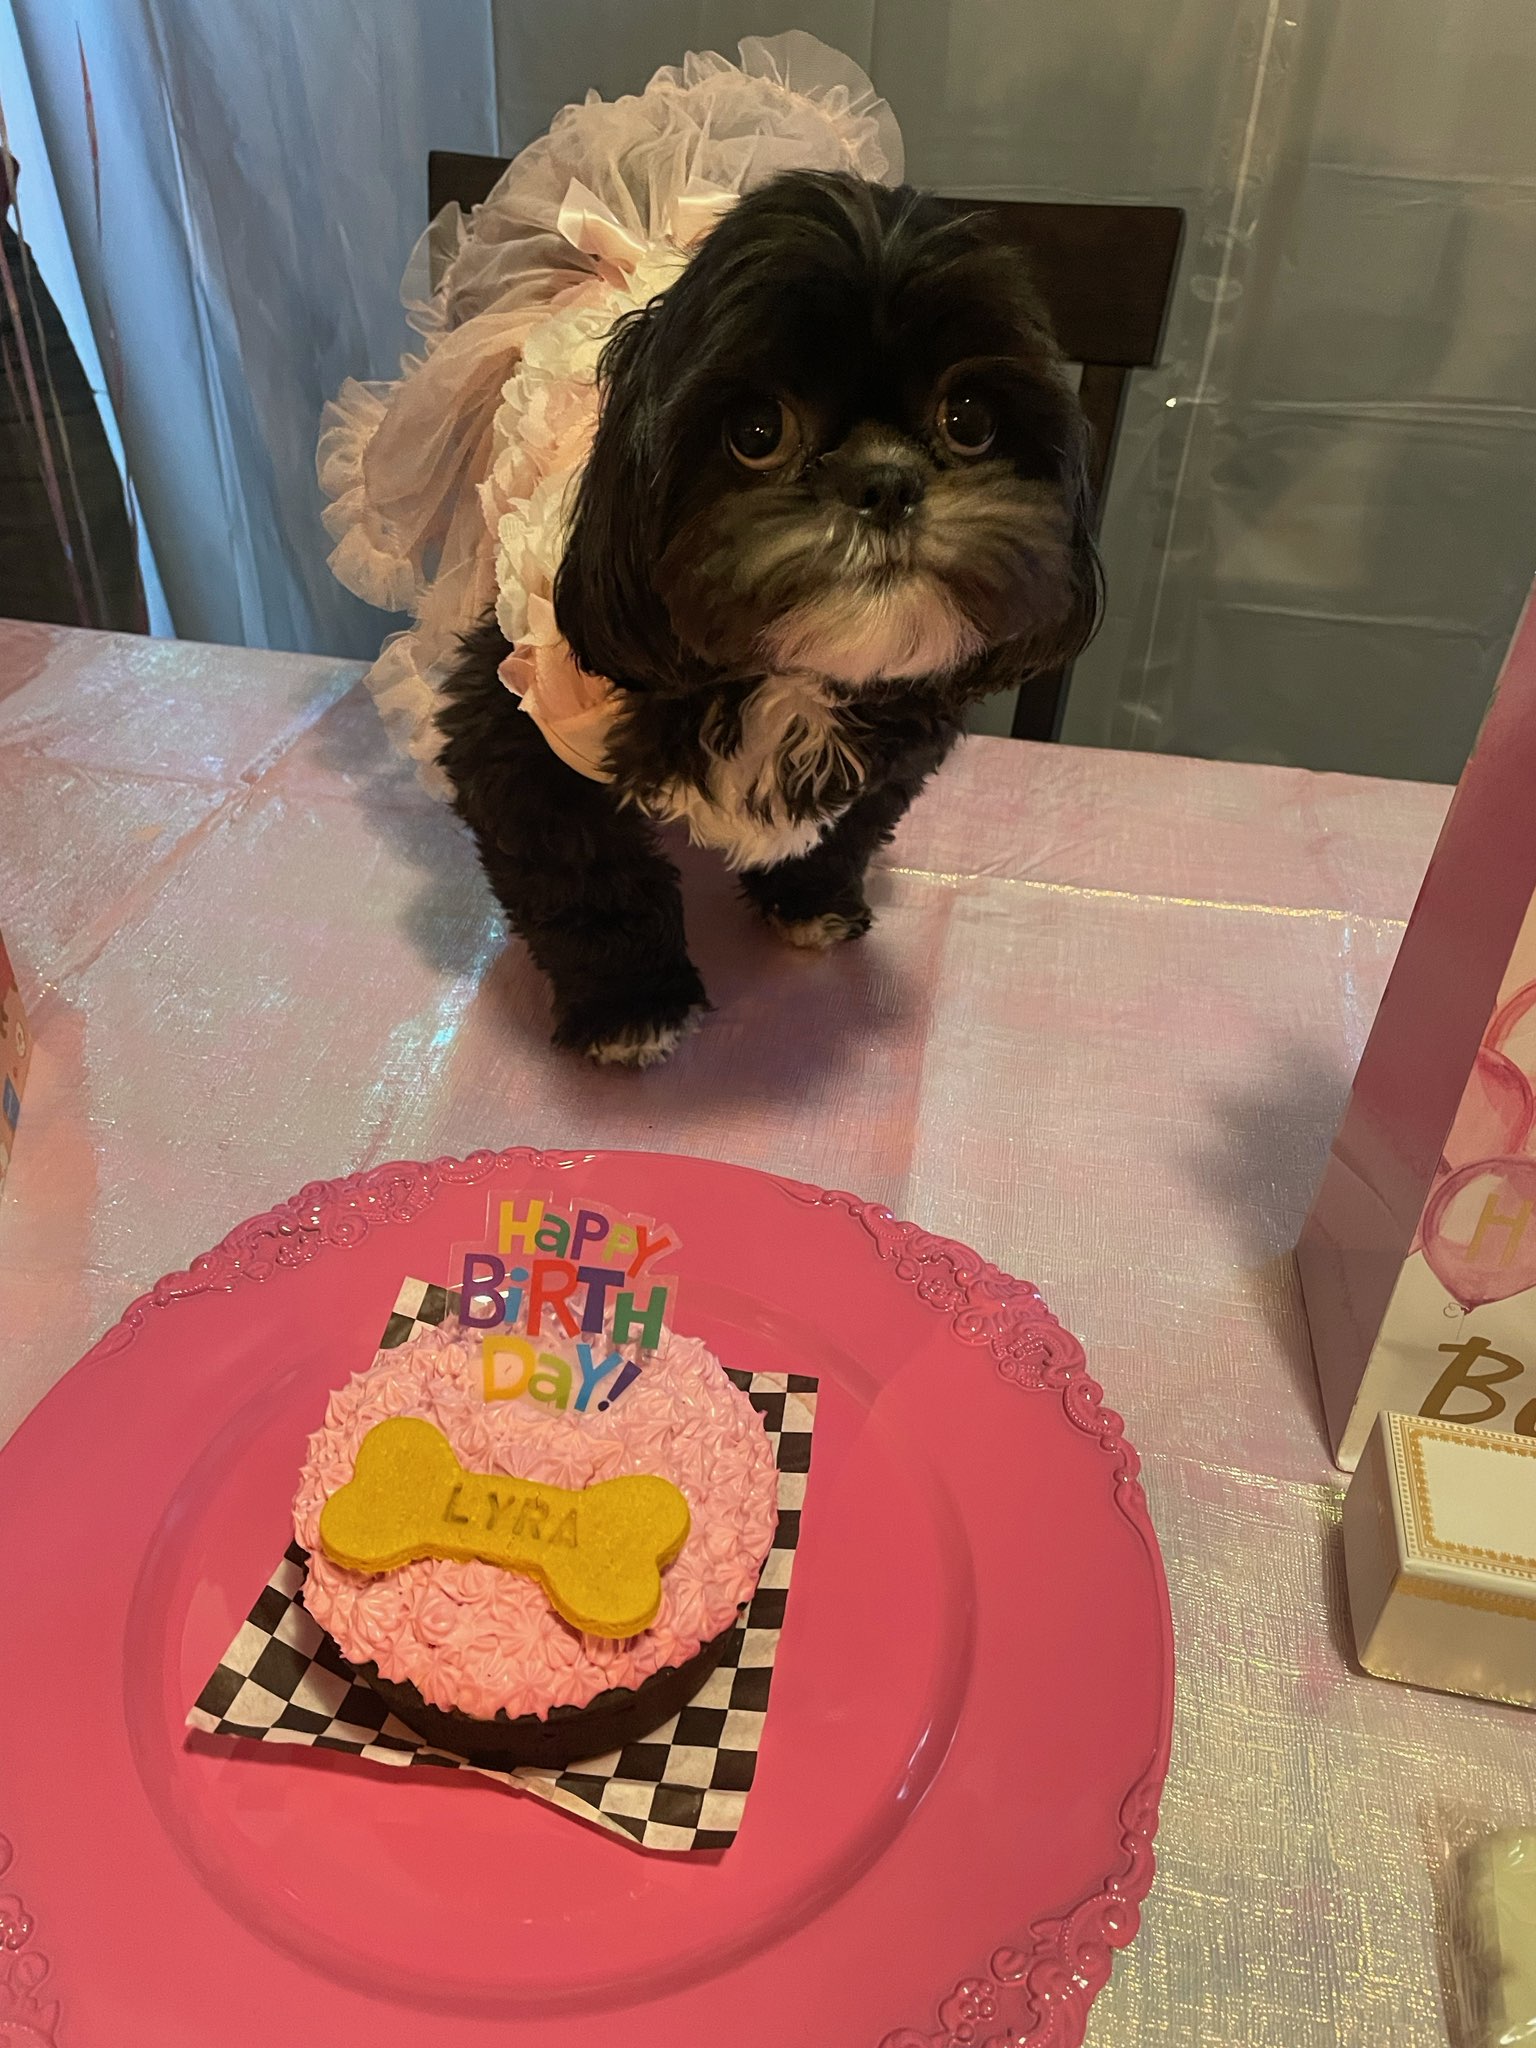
[438,172,1100,1067]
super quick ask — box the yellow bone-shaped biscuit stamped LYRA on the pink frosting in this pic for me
[319,1415,688,1636]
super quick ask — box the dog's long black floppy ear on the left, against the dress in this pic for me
[555,301,676,686]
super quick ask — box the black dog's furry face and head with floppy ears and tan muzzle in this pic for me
[555,174,1098,698]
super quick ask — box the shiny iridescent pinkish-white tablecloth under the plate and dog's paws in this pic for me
[0,625,1536,2048]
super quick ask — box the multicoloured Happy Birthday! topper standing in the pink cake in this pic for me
[449,1194,682,1415]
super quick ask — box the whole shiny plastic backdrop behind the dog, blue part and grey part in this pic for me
[14,0,1536,780]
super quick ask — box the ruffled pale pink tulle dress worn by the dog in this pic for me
[317,31,901,793]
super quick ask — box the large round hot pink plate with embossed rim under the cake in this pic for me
[0,1151,1174,2048]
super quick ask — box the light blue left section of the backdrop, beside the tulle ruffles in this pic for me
[0,0,496,655]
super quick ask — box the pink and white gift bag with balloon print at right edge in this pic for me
[1296,600,1536,1470]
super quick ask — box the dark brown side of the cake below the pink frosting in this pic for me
[356,1622,735,1772]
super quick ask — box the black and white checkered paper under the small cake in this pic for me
[186,1280,817,1849]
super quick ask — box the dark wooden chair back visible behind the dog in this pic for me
[426,150,1184,739]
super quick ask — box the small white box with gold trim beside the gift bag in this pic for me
[1343,1413,1536,1706]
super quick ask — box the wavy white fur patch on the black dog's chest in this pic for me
[645,674,862,868]
